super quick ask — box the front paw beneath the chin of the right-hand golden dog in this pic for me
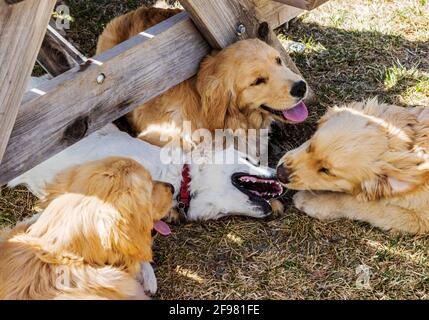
[293,191,336,220]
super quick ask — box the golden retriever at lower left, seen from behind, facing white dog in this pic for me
[0,157,172,300]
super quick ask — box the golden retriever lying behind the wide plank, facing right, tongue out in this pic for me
[97,7,308,146]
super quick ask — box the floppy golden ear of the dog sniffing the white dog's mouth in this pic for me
[359,151,428,200]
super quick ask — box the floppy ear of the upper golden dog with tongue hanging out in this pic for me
[197,56,238,130]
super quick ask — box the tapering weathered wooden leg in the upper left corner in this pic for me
[0,0,56,161]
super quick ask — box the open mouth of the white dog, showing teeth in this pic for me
[231,172,283,202]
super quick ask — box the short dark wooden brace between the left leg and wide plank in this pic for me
[37,21,87,77]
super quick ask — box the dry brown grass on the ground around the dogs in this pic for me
[0,0,429,299]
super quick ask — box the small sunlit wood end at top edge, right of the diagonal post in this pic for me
[252,0,304,29]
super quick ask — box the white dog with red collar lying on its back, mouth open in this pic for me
[9,124,283,220]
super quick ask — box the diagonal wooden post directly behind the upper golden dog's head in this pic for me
[180,0,312,87]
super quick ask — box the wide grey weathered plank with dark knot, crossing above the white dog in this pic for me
[0,12,210,185]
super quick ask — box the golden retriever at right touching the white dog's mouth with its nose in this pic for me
[277,99,429,233]
